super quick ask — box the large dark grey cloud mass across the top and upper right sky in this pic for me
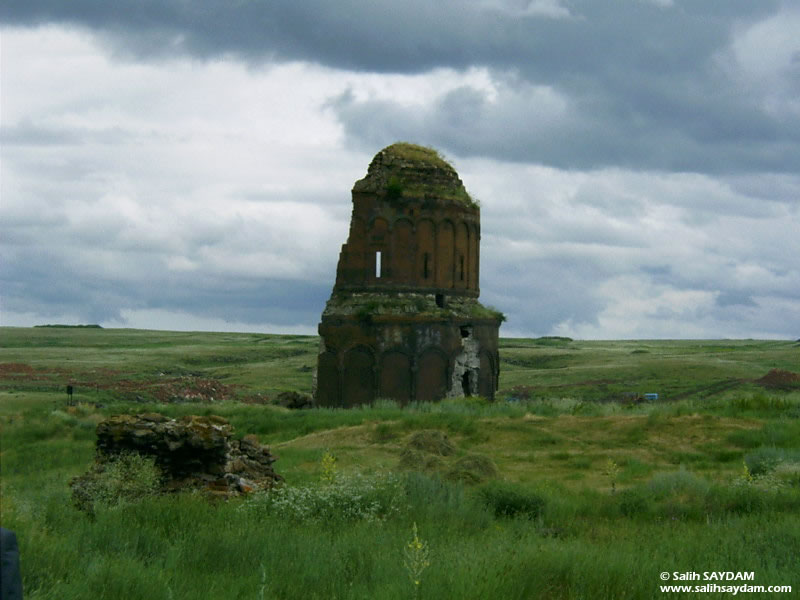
[0,0,800,173]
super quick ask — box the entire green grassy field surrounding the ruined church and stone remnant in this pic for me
[0,328,800,599]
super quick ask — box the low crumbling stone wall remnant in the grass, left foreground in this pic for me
[71,413,283,504]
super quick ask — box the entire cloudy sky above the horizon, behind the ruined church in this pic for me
[0,0,800,339]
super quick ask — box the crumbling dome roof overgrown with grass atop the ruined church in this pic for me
[353,142,475,206]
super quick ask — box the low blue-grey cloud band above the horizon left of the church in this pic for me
[0,248,334,325]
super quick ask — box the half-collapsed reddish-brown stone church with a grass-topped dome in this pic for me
[315,143,503,407]
